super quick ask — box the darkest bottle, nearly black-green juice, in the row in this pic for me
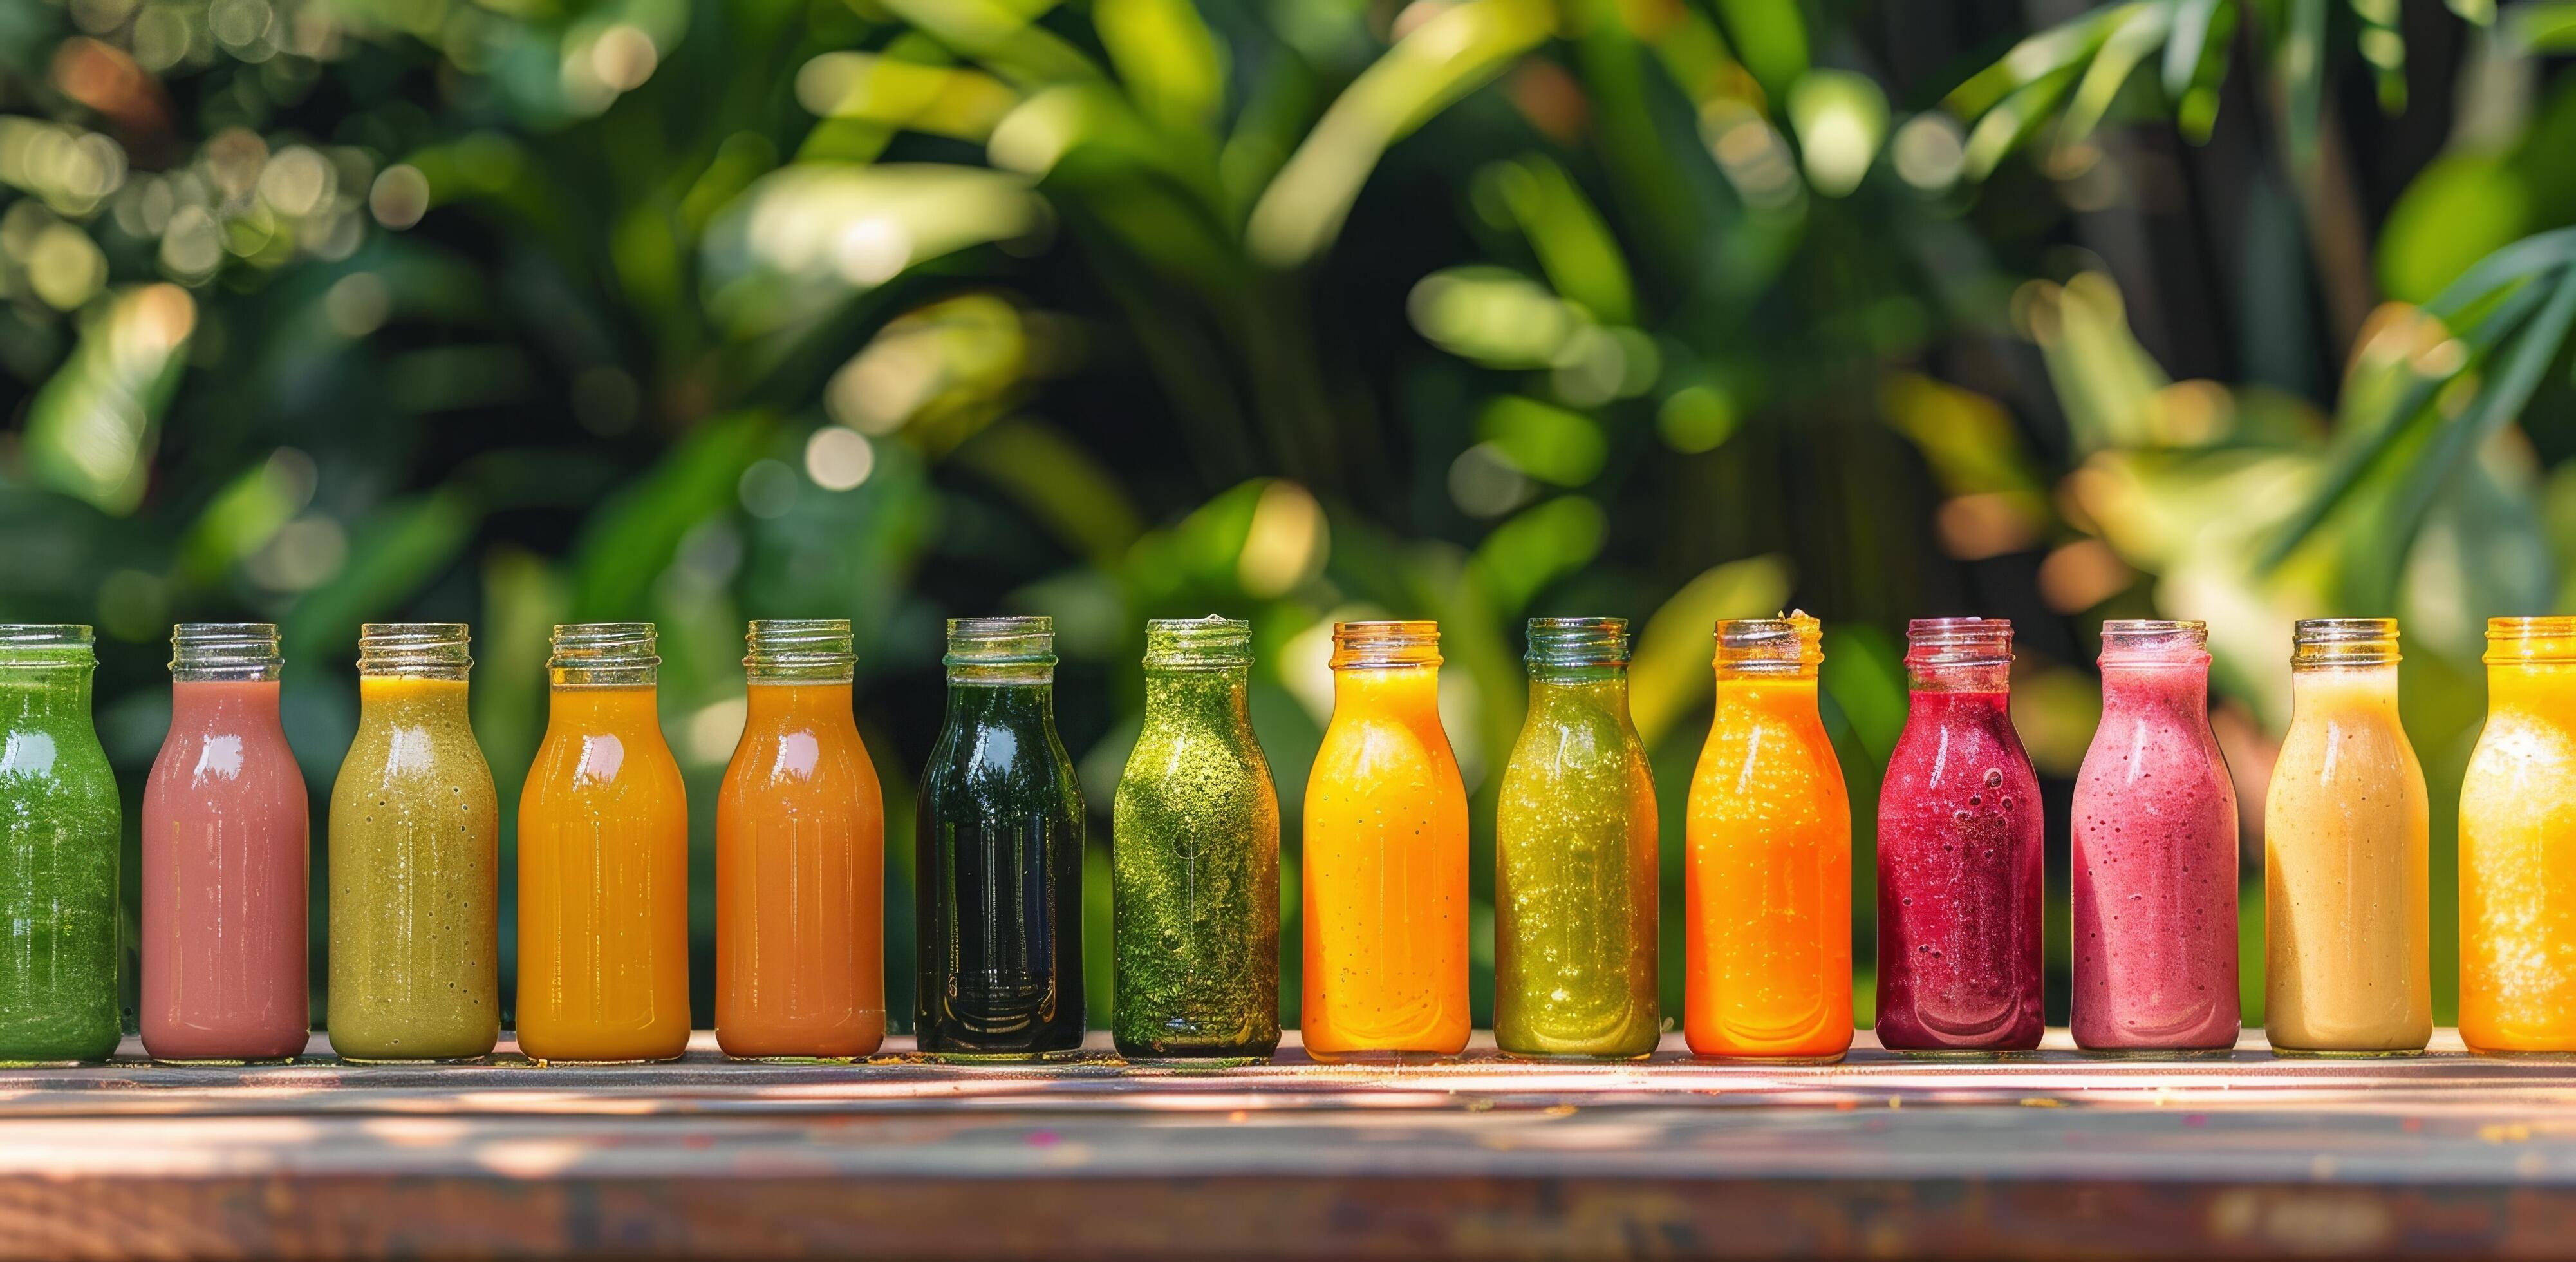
[915,618,1082,1059]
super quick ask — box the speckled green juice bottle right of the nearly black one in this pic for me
[1110,618,1280,1059]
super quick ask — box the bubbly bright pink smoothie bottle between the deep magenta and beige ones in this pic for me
[2074,621,2236,1053]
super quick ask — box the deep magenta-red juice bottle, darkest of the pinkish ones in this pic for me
[1878,618,2043,1053]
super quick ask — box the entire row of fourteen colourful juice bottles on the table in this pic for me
[0,616,2576,1061]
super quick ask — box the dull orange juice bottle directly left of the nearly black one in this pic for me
[716,618,886,1059]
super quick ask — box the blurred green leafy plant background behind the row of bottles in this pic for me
[0,0,2576,1025]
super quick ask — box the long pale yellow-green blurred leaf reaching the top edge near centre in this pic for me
[1244,0,1551,268]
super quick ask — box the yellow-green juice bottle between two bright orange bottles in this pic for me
[1494,618,1664,1059]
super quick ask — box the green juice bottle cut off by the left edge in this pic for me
[0,626,124,1064]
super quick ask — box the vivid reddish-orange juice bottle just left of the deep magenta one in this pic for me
[1682,613,1852,1061]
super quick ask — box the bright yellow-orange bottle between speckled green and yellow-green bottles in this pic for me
[1303,623,1468,1061]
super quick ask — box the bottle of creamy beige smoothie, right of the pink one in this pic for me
[2264,618,2432,1056]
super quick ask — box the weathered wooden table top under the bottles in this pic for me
[0,1030,2576,1257]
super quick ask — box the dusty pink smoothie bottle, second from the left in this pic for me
[142,623,312,1064]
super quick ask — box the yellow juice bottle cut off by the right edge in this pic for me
[2460,618,2576,1053]
